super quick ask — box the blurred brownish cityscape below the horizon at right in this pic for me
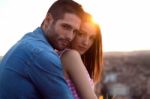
[95,51,150,99]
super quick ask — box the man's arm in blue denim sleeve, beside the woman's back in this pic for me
[28,51,73,99]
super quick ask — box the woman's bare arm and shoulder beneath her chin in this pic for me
[61,50,97,99]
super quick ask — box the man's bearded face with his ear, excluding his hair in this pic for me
[46,13,81,50]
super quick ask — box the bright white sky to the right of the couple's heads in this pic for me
[77,0,150,51]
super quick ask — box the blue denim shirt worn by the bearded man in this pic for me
[0,27,73,99]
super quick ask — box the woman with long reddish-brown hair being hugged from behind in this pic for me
[61,14,103,99]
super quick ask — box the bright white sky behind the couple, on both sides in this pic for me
[0,0,150,56]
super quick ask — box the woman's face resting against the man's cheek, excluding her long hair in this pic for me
[70,15,97,55]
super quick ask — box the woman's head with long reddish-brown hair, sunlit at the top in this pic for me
[71,13,103,81]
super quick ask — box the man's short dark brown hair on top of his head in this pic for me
[47,0,84,20]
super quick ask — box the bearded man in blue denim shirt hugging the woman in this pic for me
[0,0,84,99]
